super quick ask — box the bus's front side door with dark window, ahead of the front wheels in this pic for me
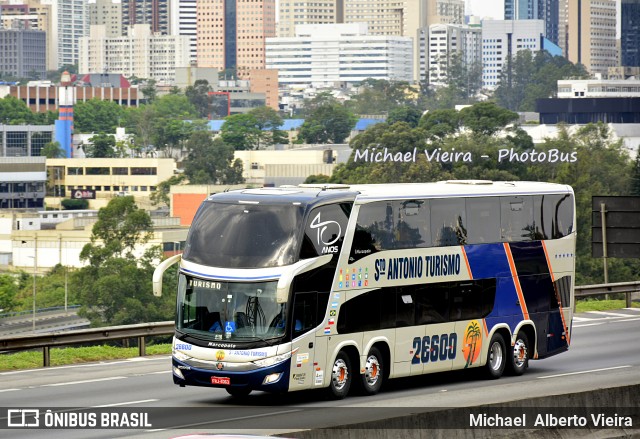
[289,291,329,390]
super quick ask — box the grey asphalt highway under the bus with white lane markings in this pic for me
[0,309,640,439]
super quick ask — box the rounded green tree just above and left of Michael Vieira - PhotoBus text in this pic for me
[299,104,358,143]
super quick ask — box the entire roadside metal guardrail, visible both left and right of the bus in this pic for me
[0,281,640,367]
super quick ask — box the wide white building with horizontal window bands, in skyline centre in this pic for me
[266,23,414,87]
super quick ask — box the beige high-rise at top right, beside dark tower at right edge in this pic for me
[567,0,618,74]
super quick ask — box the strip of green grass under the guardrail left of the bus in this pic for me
[0,344,171,370]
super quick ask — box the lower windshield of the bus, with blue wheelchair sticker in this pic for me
[176,273,286,342]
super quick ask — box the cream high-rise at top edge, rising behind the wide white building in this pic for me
[278,0,348,37]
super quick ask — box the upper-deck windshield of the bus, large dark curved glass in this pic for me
[183,202,303,268]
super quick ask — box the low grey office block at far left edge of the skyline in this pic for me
[0,29,47,79]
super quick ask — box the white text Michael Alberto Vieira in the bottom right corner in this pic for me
[469,413,633,428]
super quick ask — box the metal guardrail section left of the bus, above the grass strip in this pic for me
[0,321,174,367]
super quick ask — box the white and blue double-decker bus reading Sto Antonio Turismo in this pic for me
[154,181,576,398]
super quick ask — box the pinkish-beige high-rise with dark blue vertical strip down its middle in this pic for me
[197,0,276,77]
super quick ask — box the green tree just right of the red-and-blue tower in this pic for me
[73,98,124,133]
